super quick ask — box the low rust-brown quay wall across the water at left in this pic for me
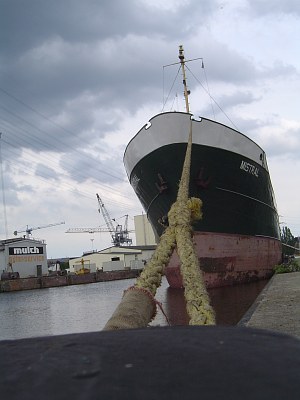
[0,270,141,293]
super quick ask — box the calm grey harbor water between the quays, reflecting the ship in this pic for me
[0,279,268,340]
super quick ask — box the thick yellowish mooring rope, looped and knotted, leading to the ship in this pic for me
[104,121,215,330]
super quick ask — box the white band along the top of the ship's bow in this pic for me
[124,112,267,177]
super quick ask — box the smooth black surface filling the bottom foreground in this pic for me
[0,326,300,400]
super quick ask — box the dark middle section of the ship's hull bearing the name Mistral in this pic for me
[131,143,279,238]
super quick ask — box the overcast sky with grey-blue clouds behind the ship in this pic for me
[0,0,300,258]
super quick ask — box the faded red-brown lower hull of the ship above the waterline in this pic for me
[165,232,282,288]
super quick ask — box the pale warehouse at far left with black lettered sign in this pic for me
[0,238,48,278]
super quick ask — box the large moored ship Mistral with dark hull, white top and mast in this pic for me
[124,46,282,288]
